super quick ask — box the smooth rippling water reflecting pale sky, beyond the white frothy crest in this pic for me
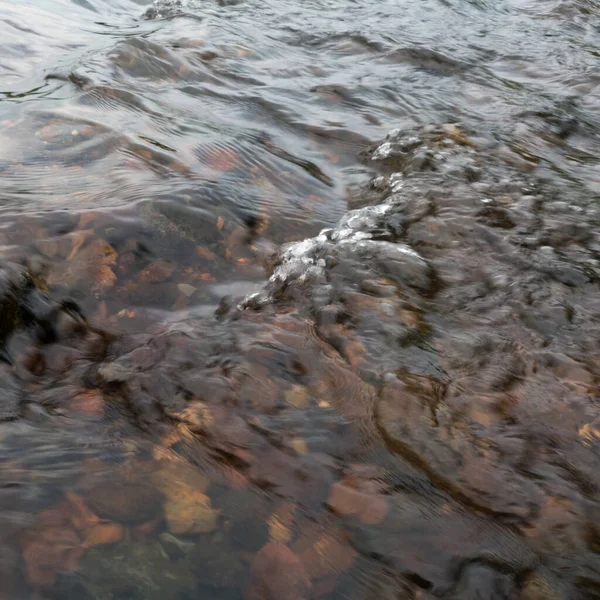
[0,0,600,318]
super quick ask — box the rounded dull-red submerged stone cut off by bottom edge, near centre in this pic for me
[246,542,310,600]
